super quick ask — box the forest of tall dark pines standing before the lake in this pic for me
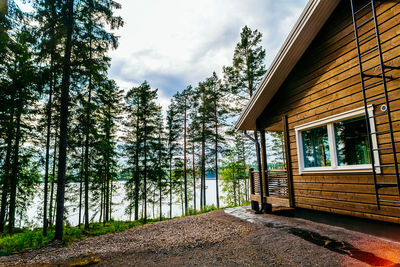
[0,0,280,242]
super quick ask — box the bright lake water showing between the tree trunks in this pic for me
[25,179,226,226]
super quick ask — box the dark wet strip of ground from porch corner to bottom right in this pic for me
[225,207,400,267]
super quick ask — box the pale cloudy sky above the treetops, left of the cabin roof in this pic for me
[109,0,307,108]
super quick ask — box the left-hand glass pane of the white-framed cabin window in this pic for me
[301,125,331,168]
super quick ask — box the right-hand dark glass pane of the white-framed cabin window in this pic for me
[334,116,371,166]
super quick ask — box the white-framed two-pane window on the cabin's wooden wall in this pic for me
[295,106,379,173]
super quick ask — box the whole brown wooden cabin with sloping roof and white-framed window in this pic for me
[236,0,400,223]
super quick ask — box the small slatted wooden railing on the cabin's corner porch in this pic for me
[249,169,289,199]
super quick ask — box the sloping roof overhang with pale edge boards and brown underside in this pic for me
[235,0,340,130]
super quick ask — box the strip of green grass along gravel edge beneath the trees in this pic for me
[0,205,231,256]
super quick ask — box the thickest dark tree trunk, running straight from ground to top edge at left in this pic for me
[54,0,74,240]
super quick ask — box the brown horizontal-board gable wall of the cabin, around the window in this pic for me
[257,0,400,223]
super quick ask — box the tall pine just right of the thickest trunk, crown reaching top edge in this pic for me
[74,0,123,229]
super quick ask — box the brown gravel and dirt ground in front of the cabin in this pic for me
[0,207,400,266]
